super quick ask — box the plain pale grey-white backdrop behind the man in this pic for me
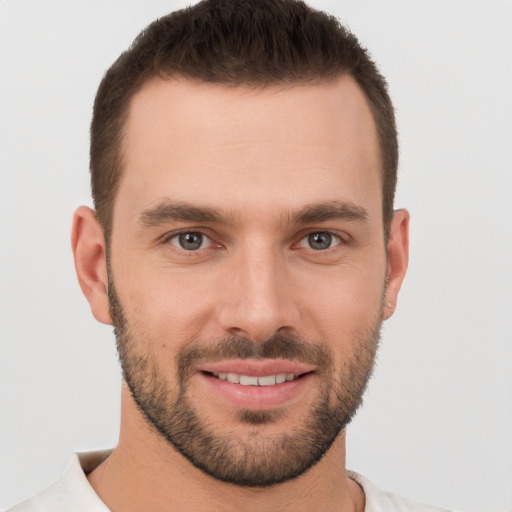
[0,0,512,512]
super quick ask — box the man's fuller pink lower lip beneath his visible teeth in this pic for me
[197,373,313,410]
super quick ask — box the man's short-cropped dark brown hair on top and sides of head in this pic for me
[90,0,398,241]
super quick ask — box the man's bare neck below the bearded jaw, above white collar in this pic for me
[88,389,364,512]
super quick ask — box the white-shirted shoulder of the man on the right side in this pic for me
[348,471,454,512]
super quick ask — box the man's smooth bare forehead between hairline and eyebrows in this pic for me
[118,76,381,224]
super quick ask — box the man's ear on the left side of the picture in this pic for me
[71,206,111,324]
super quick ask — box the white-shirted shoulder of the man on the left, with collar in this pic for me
[8,452,109,512]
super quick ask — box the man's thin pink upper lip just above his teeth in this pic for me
[198,359,315,377]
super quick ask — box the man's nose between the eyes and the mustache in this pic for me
[218,244,300,343]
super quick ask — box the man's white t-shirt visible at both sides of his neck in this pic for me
[9,451,447,512]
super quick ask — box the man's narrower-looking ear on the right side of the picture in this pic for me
[384,210,409,320]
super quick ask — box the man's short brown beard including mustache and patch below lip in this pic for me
[108,281,382,487]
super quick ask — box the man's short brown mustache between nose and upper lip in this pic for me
[176,333,334,382]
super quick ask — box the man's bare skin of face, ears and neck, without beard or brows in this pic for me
[72,73,409,512]
